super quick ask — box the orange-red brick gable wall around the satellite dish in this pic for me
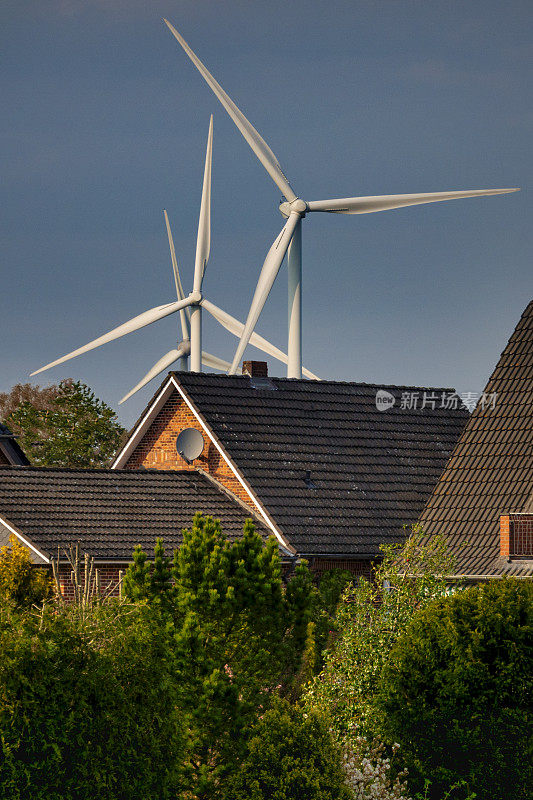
[124,392,259,511]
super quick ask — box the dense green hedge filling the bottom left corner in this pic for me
[0,602,185,800]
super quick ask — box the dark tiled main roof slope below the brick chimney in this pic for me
[156,372,468,558]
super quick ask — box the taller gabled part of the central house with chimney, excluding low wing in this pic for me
[113,362,468,576]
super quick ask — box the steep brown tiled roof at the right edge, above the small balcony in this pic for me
[421,301,533,576]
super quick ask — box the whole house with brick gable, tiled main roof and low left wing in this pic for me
[0,362,468,597]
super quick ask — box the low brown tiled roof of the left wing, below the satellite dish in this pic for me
[0,467,271,562]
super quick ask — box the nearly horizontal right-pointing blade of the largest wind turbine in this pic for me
[307,189,520,214]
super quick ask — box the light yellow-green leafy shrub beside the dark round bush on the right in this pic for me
[305,528,452,746]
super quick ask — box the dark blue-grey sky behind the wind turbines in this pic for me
[0,0,533,424]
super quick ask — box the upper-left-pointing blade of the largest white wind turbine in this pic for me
[164,19,296,202]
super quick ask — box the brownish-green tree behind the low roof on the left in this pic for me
[5,379,124,469]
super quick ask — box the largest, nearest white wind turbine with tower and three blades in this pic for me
[164,19,519,378]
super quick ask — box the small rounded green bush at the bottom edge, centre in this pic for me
[223,700,350,800]
